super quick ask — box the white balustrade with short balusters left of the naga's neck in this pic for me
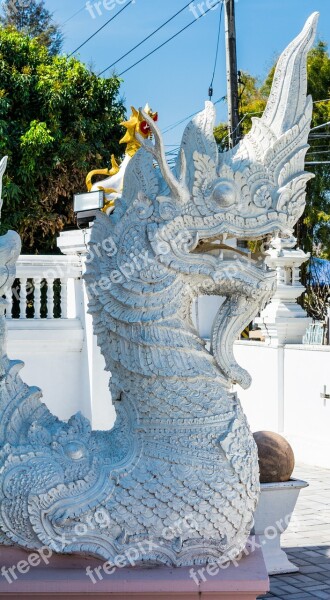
[6,255,82,319]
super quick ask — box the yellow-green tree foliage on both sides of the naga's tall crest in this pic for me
[215,41,330,259]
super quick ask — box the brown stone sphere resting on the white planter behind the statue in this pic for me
[253,431,295,483]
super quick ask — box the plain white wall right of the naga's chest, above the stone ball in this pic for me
[235,341,330,469]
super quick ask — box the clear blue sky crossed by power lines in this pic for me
[46,0,330,145]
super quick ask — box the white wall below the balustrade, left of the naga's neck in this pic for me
[7,280,115,430]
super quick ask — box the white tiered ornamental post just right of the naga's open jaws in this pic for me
[255,237,311,346]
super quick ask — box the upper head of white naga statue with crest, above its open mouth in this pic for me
[123,13,318,260]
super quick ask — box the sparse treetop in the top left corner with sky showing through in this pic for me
[0,0,63,54]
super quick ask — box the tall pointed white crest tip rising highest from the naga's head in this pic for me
[261,12,319,137]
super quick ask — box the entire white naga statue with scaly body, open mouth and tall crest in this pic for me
[0,14,318,566]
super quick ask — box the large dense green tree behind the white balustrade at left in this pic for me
[0,28,125,253]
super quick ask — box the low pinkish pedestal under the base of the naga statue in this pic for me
[0,544,269,600]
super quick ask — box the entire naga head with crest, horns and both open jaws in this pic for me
[87,13,318,388]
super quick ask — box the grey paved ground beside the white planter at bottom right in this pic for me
[260,466,330,600]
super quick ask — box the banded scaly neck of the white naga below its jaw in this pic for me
[101,277,232,420]
